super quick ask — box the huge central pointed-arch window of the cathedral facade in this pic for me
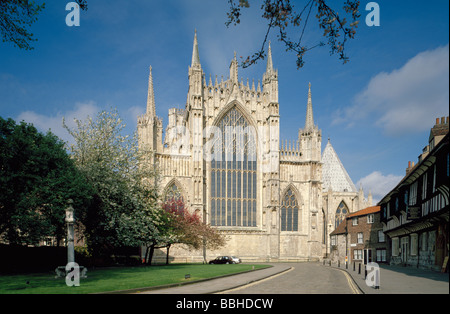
[210,107,257,227]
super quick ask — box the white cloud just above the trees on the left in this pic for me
[16,101,99,142]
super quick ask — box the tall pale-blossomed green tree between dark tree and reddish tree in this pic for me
[64,110,162,254]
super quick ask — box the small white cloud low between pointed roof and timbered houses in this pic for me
[356,171,403,204]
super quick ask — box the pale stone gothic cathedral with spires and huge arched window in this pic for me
[138,34,372,262]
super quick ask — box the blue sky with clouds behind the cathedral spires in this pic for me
[0,0,449,204]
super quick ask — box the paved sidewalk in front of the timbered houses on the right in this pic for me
[331,263,449,294]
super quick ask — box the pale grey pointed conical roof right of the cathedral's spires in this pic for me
[322,140,357,192]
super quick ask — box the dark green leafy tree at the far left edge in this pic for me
[0,117,91,245]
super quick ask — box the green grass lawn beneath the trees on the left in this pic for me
[0,264,268,294]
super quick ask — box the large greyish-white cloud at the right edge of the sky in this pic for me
[333,44,449,135]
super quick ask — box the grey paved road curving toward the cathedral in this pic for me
[223,263,360,294]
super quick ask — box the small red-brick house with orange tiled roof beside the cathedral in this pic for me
[330,206,386,264]
